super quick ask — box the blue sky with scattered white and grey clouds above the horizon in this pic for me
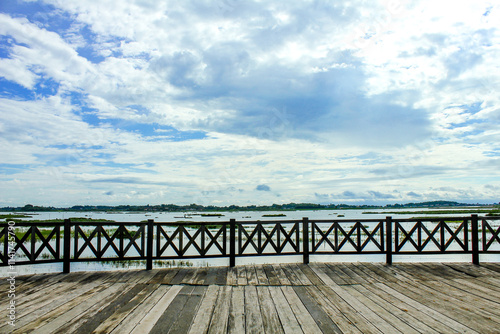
[0,0,500,206]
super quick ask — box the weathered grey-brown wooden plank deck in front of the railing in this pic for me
[0,263,500,334]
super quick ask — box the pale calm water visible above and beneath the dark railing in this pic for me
[0,208,500,277]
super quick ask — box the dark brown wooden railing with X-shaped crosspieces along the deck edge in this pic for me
[0,215,500,273]
